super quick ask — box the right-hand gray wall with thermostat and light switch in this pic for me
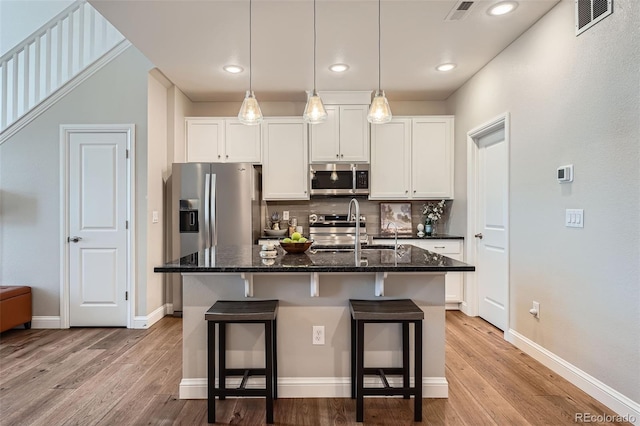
[448,0,640,402]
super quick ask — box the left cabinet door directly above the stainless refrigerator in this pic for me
[185,119,224,163]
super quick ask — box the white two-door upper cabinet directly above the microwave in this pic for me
[309,92,370,163]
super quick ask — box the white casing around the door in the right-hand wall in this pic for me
[460,112,511,336]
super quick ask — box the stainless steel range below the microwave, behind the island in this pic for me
[309,213,369,245]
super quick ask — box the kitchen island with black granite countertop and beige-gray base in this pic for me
[155,245,475,399]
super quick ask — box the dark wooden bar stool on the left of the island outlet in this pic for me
[204,300,278,423]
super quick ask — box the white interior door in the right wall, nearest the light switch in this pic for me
[475,123,509,331]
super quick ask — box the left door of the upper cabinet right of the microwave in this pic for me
[369,118,411,200]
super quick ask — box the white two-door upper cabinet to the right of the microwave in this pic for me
[369,116,453,200]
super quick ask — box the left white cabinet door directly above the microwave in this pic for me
[309,105,340,163]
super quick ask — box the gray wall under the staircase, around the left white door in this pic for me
[0,47,152,316]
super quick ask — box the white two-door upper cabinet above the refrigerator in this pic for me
[185,117,261,163]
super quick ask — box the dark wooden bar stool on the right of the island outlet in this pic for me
[349,299,424,422]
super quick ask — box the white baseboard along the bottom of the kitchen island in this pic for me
[180,377,449,399]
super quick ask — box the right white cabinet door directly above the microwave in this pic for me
[340,105,369,163]
